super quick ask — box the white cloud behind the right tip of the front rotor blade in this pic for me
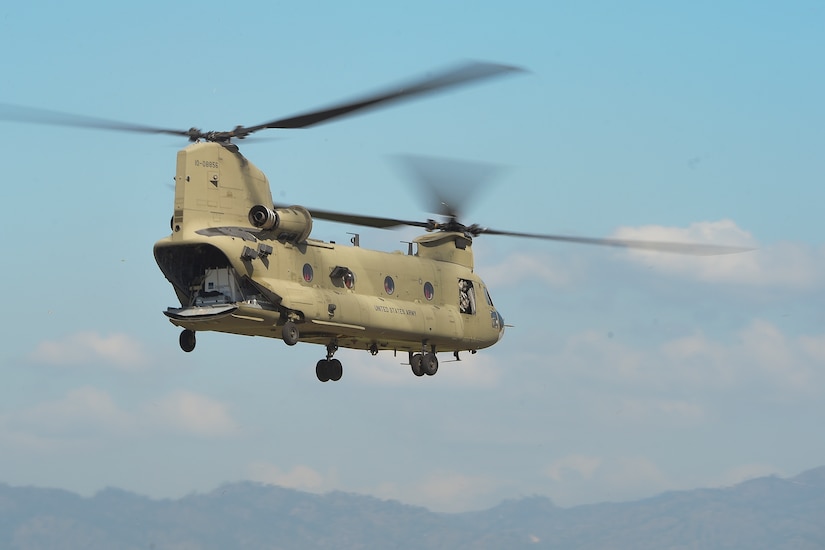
[612,220,825,289]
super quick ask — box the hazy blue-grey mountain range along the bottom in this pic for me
[0,467,825,550]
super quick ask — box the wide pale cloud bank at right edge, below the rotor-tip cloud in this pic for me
[548,319,825,396]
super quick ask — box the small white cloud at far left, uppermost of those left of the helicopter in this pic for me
[29,331,147,369]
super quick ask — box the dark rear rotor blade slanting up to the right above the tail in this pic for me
[235,62,523,136]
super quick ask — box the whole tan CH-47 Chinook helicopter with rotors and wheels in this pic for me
[0,62,745,382]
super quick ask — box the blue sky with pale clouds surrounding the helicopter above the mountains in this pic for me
[0,1,825,511]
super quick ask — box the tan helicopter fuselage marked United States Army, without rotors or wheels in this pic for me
[154,142,504,353]
